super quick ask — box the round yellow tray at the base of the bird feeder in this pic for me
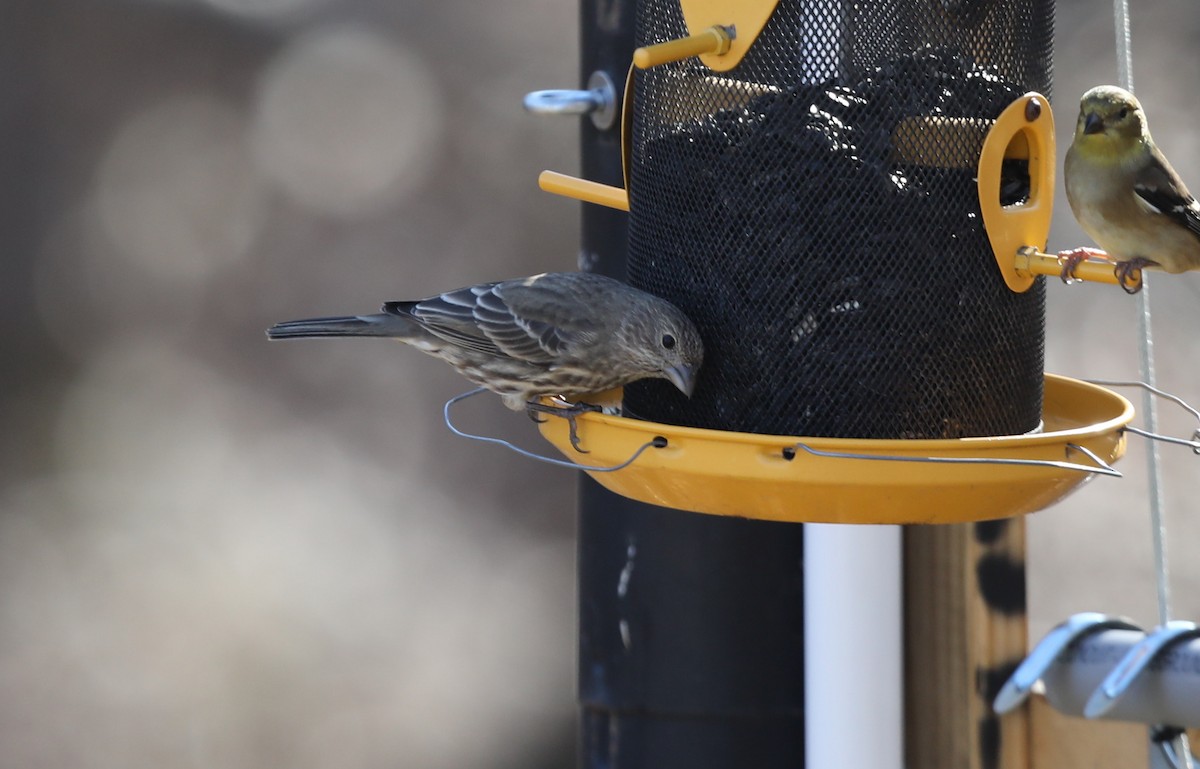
[540,374,1134,523]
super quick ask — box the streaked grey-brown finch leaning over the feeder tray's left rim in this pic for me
[266,272,704,450]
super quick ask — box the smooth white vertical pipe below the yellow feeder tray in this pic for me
[804,523,904,769]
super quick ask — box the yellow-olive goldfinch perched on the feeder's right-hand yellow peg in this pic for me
[1058,85,1200,293]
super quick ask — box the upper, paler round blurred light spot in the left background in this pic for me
[253,25,443,217]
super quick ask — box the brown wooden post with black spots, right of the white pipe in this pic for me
[905,518,1031,769]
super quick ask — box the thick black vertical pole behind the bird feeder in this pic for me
[578,0,804,769]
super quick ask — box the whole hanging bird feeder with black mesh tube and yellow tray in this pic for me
[541,0,1133,523]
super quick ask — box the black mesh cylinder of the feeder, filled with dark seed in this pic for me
[625,0,1054,438]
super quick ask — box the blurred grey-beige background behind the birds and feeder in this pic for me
[0,0,1200,769]
